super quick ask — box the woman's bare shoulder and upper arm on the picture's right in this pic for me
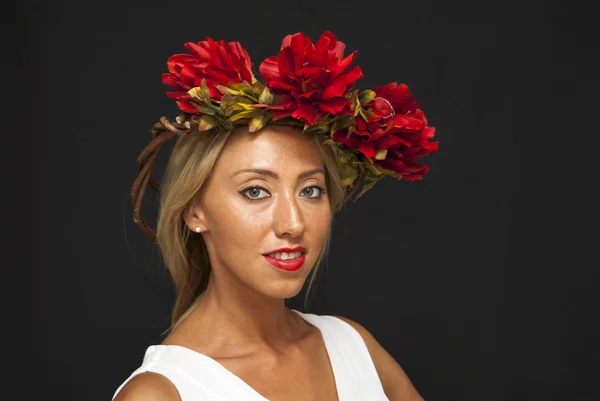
[336,316,423,401]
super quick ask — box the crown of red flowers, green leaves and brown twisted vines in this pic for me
[131,32,438,241]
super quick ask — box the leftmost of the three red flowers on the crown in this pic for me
[162,38,252,114]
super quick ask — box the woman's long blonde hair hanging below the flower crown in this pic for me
[156,127,345,326]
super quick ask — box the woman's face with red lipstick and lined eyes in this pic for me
[187,126,331,299]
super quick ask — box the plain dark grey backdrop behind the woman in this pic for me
[8,0,600,401]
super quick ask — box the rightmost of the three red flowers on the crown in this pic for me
[333,82,438,181]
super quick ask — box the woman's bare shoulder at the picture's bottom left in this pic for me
[114,372,181,401]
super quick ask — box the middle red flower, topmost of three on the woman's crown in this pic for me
[260,32,363,124]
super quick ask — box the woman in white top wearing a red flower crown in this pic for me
[113,33,437,401]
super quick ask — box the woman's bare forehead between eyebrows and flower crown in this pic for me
[214,126,323,174]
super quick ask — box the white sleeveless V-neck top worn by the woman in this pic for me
[113,309,389,401]
